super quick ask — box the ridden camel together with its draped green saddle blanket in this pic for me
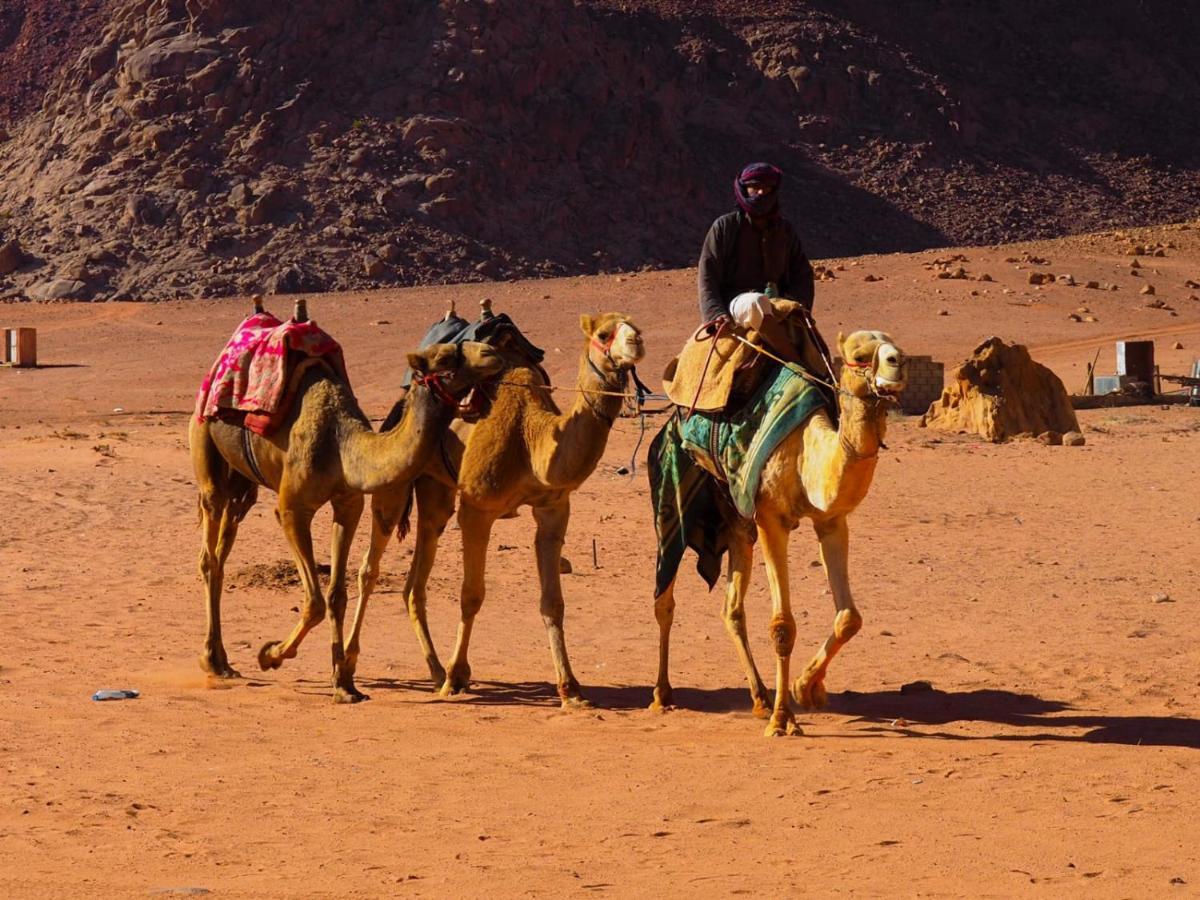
[649,301,906,736]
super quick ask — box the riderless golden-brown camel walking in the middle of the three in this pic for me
[347,312,644,708]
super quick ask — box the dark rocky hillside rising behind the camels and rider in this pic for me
[0,0,1200,299]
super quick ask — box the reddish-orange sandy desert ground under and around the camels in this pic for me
[0,228,1200,898]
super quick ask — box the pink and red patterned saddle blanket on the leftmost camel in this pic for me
[196,312,350,434]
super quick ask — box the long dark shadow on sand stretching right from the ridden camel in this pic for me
[827,690,1200,750]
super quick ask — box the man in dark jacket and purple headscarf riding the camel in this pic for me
[698,162,814,358]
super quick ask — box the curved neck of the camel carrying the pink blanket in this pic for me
[342,384,454,493]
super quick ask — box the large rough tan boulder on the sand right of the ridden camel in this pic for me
[922,337,1079,443]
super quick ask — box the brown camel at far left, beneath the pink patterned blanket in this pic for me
[188,326,504,703]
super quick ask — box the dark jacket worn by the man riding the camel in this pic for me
[698,210,812,322]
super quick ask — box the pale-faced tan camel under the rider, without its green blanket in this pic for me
[650,331,905,737]
